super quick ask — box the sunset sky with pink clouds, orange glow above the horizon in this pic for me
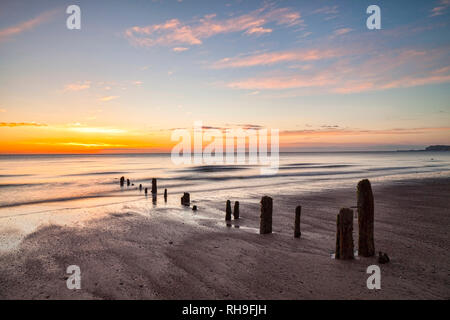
[0,0,450,153]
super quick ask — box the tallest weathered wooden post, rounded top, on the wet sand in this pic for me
[356,179,375,257]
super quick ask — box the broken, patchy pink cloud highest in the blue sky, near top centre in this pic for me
[124,5,303,47]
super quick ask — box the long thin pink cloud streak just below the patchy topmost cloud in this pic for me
[212,49,344,69]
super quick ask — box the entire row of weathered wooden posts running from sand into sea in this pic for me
[120,177,375,259]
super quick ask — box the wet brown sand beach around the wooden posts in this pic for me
[0,178,450,299]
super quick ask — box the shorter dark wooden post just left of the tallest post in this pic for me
[335,208,354,260]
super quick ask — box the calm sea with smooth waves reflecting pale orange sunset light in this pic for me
[0,152,450,210]
